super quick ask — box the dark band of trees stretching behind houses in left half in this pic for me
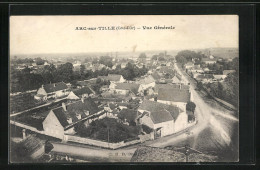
[10,62,148,93]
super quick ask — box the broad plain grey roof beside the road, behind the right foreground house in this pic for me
[157,89,190,103]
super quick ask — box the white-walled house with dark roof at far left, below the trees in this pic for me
[34,82,70,100]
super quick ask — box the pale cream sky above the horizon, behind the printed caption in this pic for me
[10,15,239,55]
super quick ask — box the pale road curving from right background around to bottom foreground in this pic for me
[49,64,238,162]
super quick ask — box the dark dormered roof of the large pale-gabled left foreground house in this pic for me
[52,98,100,127]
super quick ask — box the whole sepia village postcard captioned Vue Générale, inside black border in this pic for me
[9,15,239,164]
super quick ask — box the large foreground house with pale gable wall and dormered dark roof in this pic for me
[42,98,102,139]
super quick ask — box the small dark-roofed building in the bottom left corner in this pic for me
[16,135,45,159]
